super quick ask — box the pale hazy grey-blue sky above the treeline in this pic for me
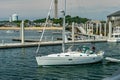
[0,0,120,20]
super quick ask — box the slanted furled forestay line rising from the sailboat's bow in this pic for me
[36,0,53,54]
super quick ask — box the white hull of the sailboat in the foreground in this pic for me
[36,53,103,66]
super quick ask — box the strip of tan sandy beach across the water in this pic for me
[0,27,62,30]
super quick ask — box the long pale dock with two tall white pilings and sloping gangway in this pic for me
[0,21,107,49]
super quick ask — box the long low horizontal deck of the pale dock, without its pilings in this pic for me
[0,39,107,49]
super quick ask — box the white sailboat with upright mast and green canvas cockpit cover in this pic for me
[36,0,104,66]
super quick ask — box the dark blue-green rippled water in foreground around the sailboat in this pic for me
[0,29,120,80]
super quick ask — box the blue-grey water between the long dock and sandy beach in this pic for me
[0,30,62,43]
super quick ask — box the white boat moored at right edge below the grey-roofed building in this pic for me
[107,26,120,42]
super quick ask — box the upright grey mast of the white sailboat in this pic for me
[62,0,66,53]
